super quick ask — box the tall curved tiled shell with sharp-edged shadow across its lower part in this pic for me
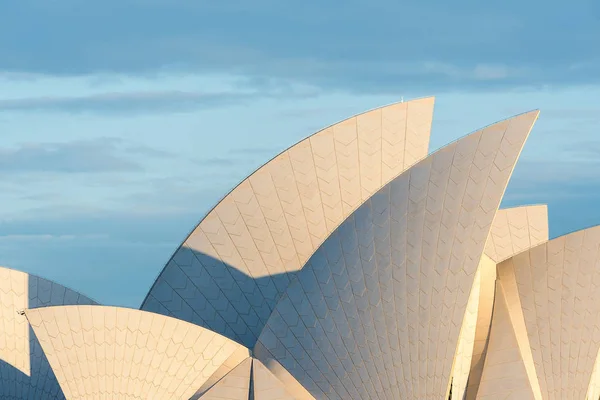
[142,98,434,347]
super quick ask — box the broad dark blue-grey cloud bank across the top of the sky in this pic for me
[0,0,600,92]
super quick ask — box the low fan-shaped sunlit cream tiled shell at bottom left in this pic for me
[26,306,246,400]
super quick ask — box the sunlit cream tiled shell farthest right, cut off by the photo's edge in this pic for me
[483,227,600,399]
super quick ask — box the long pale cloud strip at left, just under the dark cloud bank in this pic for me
[0,72,319,115]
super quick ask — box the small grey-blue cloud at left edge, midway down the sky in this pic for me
[0,138,153,174]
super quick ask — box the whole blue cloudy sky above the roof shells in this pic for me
[0,0,600,307]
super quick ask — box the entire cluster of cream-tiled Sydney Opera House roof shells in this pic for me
[0,98,600,400]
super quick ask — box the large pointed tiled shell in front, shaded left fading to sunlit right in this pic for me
[258,112,538,399]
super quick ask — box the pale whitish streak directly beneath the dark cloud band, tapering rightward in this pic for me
[0,71,319,106]
